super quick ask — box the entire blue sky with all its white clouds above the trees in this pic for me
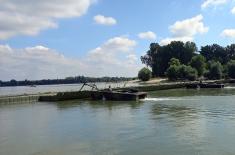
[0,0,235,80]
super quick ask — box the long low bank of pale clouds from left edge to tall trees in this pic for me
[0,37,142,80]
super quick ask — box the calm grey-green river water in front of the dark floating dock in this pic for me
[0,87,235,155]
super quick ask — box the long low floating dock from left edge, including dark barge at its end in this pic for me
[0,91,147,105]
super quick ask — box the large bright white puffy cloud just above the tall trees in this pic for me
[160,15,209,45]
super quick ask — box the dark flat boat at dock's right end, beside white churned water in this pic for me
[91,90,147,101]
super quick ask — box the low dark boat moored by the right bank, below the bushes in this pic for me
[186,83,224,89]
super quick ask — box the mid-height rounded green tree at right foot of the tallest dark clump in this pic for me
[190,55,206,76]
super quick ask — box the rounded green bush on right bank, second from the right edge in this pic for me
[205,61,223,80]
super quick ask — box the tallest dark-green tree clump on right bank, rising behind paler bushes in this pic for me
[141,41,197,76]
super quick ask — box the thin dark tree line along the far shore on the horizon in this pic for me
[0,76,132,87]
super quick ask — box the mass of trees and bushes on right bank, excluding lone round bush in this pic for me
[141,41,235,80]
